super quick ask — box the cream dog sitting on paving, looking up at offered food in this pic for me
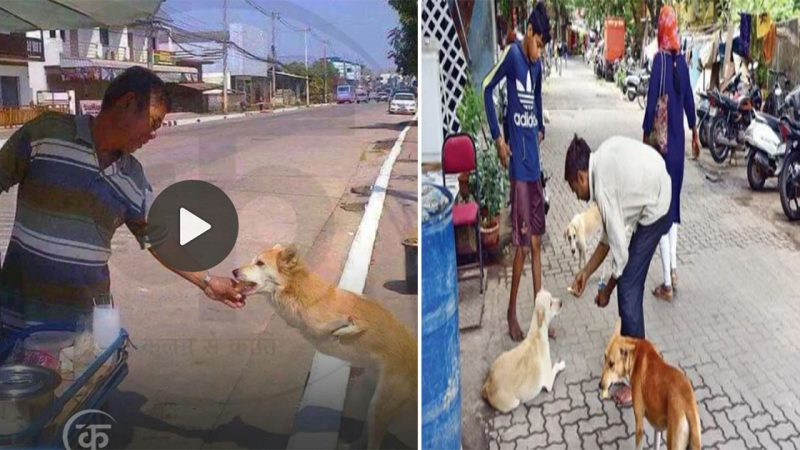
[481,290,566,413]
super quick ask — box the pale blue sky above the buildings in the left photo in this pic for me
[161,0,399,71]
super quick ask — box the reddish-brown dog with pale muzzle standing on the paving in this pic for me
[600,321,701,450]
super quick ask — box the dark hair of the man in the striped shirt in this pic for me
[100,66,169,111]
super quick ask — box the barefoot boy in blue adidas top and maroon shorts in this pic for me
[483,2,550,341]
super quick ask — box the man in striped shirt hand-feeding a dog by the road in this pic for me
[0,67,244,334]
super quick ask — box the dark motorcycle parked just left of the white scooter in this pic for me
[708,74,761,164]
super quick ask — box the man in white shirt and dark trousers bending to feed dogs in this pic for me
[564,135,672,394]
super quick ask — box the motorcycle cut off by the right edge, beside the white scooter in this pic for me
[778,116,800,220]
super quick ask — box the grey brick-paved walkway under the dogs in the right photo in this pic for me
[461,59,800,449]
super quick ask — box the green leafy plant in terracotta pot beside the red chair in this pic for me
[456,86,509,251]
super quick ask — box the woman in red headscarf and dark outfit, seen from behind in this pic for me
[642,6,700,300]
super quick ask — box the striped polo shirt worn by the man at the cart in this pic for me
[0,112,153,327]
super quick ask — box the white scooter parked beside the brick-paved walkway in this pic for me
[744,112,786,191]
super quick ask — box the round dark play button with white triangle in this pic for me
[147,180,239,272]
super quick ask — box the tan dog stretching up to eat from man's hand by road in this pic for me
[233,245,417,448]
